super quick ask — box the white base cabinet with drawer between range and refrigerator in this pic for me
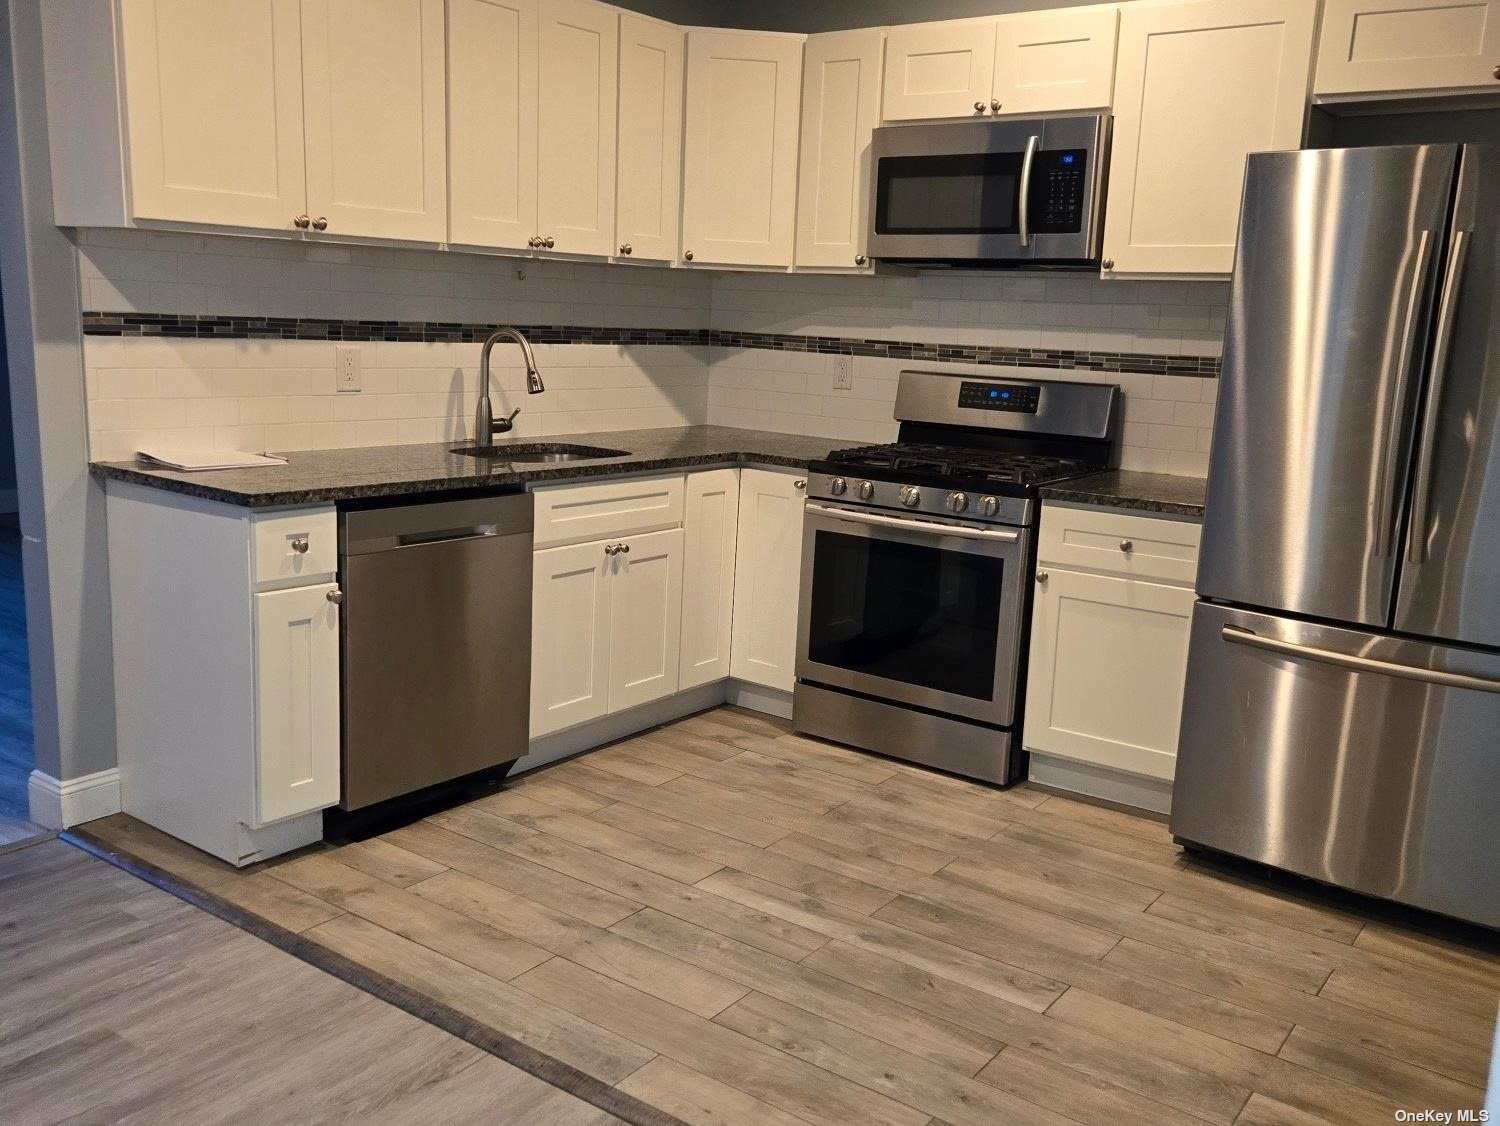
[1023,504,1202,811]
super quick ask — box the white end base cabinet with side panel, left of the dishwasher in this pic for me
[105,483,342,865]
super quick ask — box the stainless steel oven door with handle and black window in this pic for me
[797,502,1031,727]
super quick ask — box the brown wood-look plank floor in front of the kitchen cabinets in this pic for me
[90,708,1500,1126]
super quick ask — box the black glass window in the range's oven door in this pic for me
[807,531,1005,700]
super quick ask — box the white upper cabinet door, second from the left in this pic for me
[300,0,449,243]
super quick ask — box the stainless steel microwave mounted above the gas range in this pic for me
[870,114,1110,268]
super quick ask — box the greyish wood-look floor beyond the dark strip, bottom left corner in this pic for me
[0,840,617,1126]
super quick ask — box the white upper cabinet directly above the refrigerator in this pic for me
[1313,0,1500,97]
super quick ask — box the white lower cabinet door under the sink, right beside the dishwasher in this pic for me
[531,543,614,739]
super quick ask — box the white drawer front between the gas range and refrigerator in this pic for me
[1037,504,1203,586]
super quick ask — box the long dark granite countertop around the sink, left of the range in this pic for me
[90,426,849,508]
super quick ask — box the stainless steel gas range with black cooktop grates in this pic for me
[792,372,1119,784]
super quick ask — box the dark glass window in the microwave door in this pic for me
[875,153,1022,234]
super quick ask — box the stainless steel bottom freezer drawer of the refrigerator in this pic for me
[1172,601,1500,927]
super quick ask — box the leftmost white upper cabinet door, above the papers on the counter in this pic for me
[119,0,306,231]
